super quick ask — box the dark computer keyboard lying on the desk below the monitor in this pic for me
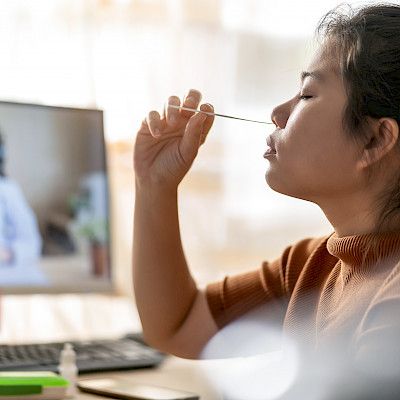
[0,334,165,374]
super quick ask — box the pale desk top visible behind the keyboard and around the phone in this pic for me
[0,295,222,400]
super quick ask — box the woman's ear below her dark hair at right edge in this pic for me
[358,118,399,169]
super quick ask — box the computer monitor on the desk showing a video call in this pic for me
[0,101,112,294]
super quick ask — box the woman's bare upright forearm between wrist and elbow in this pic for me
[133,184,197,345]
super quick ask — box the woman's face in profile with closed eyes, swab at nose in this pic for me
[264,46,359,204]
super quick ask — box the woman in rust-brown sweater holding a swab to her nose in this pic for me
[133,4,400,398]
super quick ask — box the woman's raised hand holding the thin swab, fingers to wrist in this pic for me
[134,89,214,188]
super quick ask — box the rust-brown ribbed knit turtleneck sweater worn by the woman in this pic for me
[206,233,400,351]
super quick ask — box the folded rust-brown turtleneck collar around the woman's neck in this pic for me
[327,232,400,268]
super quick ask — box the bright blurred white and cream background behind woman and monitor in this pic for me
[0,0,366,294]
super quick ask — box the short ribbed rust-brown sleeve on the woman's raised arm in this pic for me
[206,237,326,329]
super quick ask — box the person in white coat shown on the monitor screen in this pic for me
[0,136,42,267]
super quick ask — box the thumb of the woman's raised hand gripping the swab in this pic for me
[179,113,207,164]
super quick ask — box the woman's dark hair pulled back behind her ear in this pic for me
[316,3,400,233]
